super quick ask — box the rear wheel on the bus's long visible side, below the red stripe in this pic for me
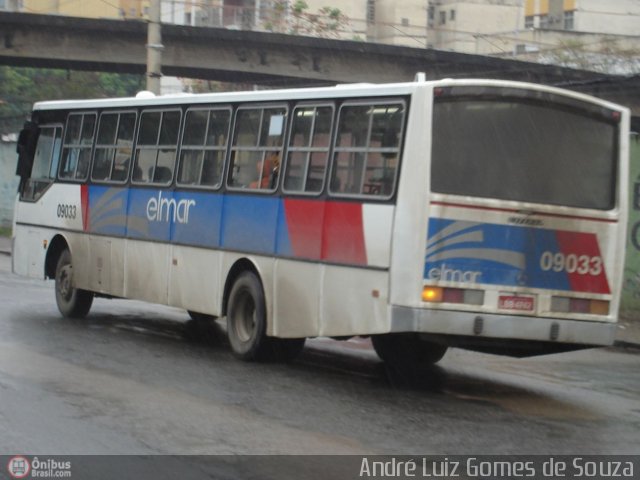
[227,272,274,362]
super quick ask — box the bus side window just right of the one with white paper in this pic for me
[284,105,333,193]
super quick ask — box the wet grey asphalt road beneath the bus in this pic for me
[0,255,640,468]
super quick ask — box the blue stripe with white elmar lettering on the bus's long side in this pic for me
[89,186,292,256]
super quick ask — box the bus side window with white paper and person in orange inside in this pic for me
[227,105,287,191]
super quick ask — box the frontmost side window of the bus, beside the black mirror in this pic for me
[21,125,62,200]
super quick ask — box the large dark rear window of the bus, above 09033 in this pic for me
[431,96,617,210]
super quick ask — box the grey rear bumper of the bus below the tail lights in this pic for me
[391,306,617,346]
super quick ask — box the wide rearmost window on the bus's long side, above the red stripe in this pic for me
[329,101,405,198]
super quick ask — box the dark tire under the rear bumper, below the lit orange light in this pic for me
[371,333,447,368]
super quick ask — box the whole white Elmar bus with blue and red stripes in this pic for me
[13,80,629,365]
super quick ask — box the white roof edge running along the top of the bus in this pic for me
[33,79,620,110]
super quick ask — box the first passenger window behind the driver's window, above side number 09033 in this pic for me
[59,113,97,181]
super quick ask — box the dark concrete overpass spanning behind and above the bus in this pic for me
[0,12,640,113]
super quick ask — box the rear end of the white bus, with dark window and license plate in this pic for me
[382,81,629,360]
